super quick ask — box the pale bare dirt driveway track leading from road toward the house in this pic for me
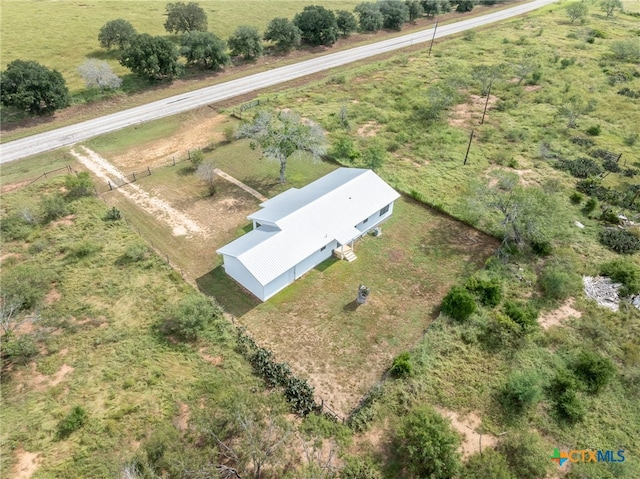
[71,146,204,236]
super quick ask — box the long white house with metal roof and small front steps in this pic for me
[217,168,400,301]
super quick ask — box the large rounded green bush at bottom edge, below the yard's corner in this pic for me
[396,406,460,479]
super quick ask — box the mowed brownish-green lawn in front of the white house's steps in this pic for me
[205,198,498,415]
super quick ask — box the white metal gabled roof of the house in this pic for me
[217,168,400,285]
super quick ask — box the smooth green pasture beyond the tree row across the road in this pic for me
[0,0,358,92]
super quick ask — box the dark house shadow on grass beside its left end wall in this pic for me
[196,265,260,318]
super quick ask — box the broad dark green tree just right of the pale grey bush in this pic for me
[120,33,182,80]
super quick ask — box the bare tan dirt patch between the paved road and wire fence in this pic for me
[111,108,228,171]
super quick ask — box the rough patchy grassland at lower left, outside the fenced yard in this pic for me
[0,179,296,478]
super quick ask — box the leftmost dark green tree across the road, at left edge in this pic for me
[0,60,69,115]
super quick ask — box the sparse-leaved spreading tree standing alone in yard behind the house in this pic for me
[236,110,326,183]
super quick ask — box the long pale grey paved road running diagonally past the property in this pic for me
[0,0,556,163]
